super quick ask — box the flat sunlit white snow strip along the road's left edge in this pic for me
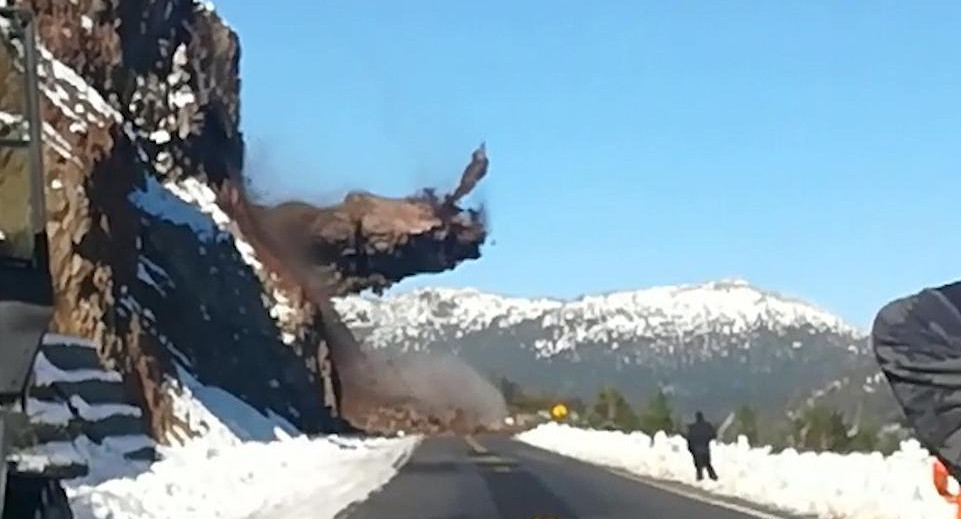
[68,436,416,519]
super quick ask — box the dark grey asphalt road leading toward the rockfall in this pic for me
[339,437,773,519]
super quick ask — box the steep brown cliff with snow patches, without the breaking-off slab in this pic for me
[1,0,341,439]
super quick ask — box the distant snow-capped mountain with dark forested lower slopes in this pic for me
[337,280,884,418]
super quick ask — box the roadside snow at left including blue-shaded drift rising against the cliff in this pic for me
[67,373,419,519]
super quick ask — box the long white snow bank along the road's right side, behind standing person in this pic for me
[517,423,954,519]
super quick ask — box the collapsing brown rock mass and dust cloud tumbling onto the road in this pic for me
[221,145,503,433]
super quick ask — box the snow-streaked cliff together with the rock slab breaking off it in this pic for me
[1,0,486,440]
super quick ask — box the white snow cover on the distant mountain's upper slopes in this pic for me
[335,280,864,356]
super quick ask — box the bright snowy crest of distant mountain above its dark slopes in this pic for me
[335,279,867,349]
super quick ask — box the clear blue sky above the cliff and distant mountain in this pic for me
[217,0,961,326]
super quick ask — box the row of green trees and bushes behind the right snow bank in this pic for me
[498,377,903,454]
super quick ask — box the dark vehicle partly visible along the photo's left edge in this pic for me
[0,8,73,519]
